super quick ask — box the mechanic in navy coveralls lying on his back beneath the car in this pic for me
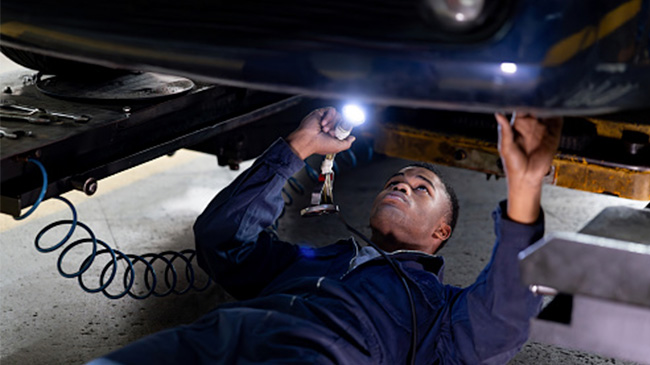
[97,108,562,365]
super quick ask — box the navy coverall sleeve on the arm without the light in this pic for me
[451,201,544,364]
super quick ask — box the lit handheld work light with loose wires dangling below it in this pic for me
[300,104,366,217]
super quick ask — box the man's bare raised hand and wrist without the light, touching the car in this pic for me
[495,114,562,223]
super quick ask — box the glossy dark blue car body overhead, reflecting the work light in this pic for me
[0,0,650,115]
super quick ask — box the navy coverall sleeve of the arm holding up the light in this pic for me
[194,139,304,299]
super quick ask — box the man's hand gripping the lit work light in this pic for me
[286,107,355,160]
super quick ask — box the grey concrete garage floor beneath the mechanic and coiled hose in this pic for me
[0,144,646,365]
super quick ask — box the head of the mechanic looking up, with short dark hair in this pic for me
[370,162,458,253]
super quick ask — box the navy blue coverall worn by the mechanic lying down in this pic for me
[96,139,544,365]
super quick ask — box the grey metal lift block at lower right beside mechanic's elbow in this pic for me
[519,207,650,364]
